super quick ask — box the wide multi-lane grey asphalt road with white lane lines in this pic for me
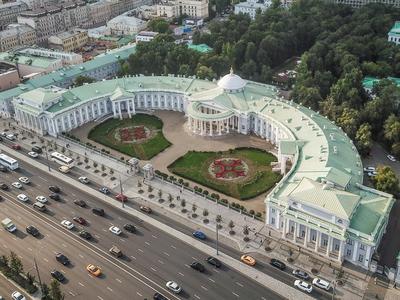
[0,152,281,299]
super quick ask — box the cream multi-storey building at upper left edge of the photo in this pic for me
[0,24,37,52]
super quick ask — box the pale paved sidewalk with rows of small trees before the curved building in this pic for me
[0,118,369,299]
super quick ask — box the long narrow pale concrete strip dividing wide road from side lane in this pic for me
[0,144,314,300]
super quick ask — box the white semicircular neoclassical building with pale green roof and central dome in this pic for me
[13,71,394,270]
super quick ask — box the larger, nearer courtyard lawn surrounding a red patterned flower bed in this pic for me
[168,148,281,200]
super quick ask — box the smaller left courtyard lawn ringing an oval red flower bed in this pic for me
[88,114,171,160]
